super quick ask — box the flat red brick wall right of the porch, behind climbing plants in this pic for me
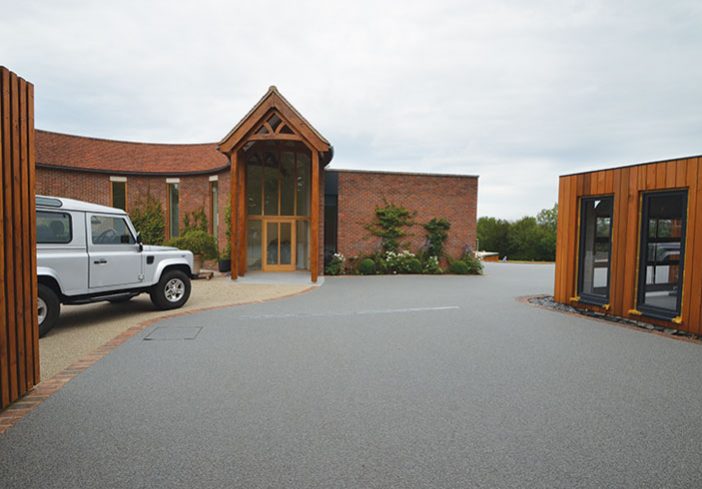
[338,171,478,258]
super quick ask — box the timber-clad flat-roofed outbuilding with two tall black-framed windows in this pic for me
[554,157,702,335]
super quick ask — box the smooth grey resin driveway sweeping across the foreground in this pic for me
[0,265,702,489]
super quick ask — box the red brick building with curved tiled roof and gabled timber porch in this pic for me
[36,87,478,281]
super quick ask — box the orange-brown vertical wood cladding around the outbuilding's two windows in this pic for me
[554,158,702,334]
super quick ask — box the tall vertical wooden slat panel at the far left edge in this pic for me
[0,67,40,408]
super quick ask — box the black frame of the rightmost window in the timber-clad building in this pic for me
[636,189,689,321]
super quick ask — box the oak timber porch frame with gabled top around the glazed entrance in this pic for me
[217,86,332,282]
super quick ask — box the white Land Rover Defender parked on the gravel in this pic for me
[36,196,193,336]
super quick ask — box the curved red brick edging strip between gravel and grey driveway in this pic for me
[0,286,315,435]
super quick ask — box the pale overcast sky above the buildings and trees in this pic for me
[0,0,702,219]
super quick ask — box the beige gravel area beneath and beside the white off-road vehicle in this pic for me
[39,276,312,380]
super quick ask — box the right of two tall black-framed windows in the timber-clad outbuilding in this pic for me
[638,191,687,319]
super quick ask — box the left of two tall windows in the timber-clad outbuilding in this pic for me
[578,197,614,305]
